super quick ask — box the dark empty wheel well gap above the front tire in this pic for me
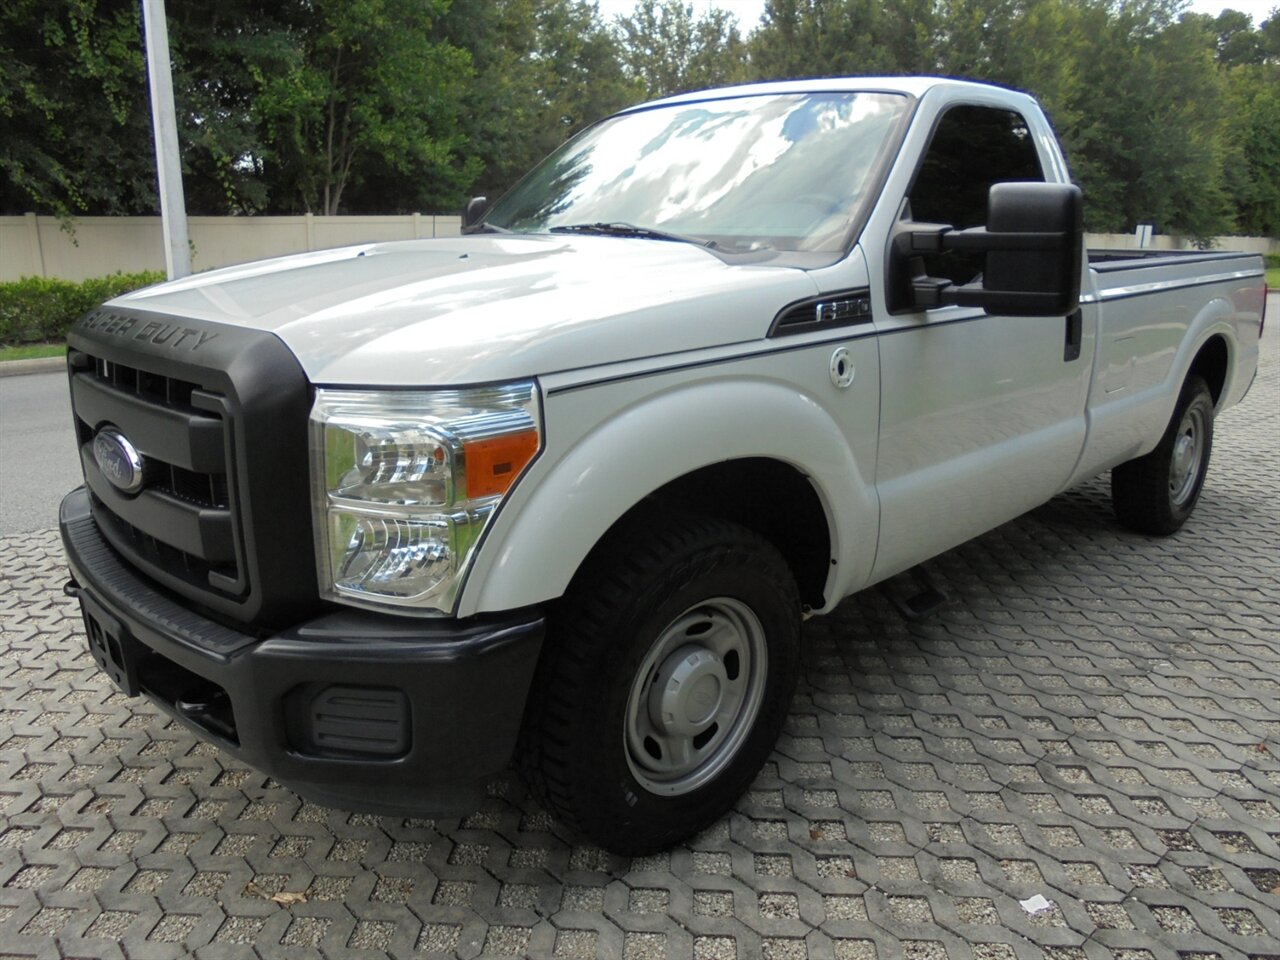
[636,457,831,607]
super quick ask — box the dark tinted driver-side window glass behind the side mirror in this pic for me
[908,106,1044,283]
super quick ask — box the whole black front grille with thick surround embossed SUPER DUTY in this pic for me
[68,304,319,631]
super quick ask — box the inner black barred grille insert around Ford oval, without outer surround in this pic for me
[72,353,244,595]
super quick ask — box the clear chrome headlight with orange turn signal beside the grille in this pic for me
[311,380,543,611]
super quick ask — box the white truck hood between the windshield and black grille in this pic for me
[113,234,817,385]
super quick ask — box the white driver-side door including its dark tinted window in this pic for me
[873,105,1088,580]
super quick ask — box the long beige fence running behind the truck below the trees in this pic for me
[0,214,1280,282]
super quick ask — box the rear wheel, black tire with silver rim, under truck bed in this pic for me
[1111,375,1213,536]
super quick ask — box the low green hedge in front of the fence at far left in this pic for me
[0,270,165,347]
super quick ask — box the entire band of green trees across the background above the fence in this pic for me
[0,0,1280,237]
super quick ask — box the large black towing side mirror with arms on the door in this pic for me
[888,183,1084,316]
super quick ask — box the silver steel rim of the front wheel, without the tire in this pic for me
[623,596,768,796]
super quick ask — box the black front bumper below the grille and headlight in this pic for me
[59,488,544,815]
